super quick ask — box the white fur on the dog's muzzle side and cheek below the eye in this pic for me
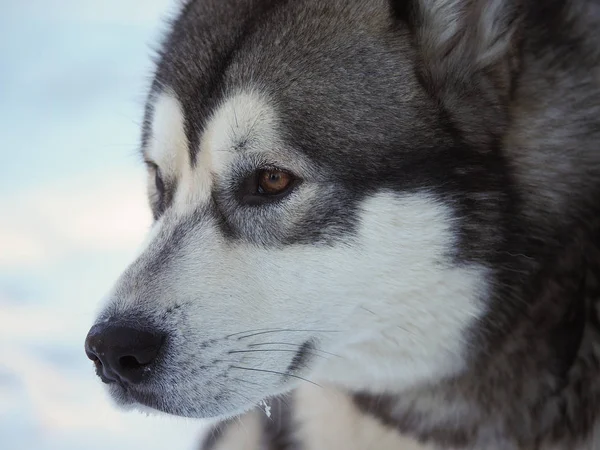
[102,185,486,415]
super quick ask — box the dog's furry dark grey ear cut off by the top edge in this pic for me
[391,0,521,146]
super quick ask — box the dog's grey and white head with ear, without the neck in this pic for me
[86,0,513,417]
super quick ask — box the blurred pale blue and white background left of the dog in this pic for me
[0,0,202,450]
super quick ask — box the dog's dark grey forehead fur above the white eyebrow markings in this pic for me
[143,0,433,172]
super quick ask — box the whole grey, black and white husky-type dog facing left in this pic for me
[86,0,600,449]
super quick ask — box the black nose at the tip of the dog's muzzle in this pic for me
[85,322,164,384]
